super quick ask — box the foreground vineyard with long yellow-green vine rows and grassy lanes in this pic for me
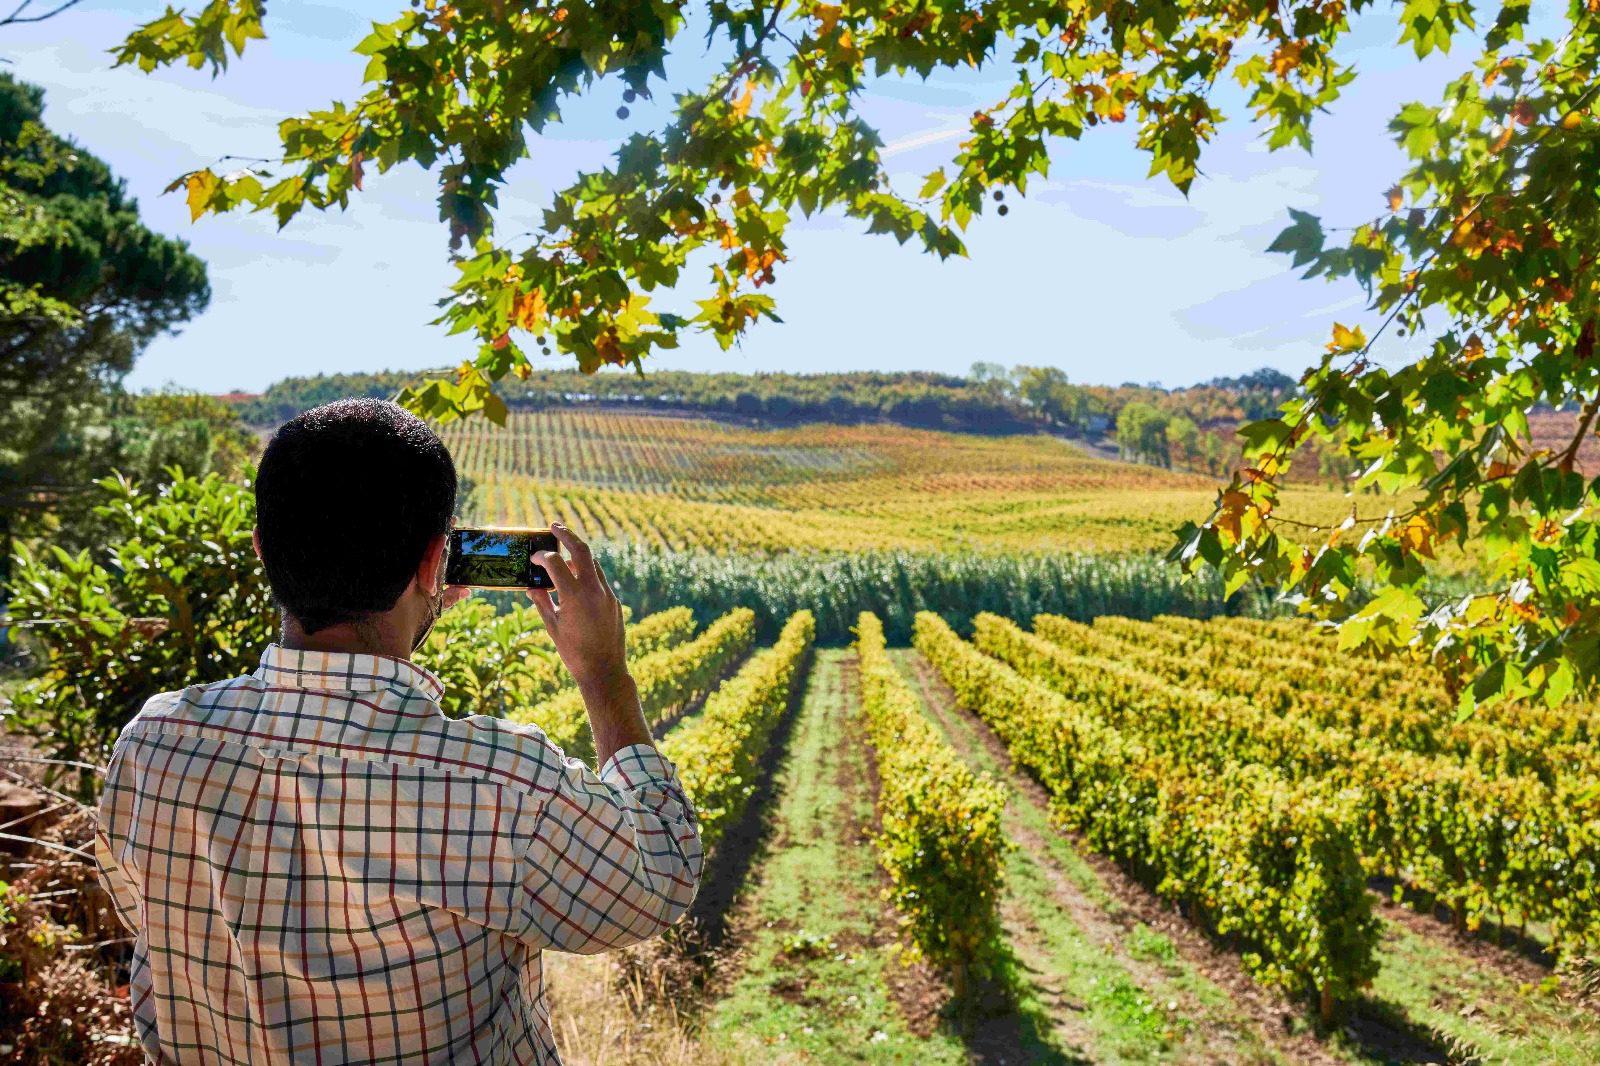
[424,592,1600,1063]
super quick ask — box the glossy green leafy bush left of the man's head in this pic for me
[6,471,277,794]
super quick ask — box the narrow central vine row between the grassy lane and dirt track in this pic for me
[856,611,1006,997]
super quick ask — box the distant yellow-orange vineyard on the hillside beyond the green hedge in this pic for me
[445,410,1349,554]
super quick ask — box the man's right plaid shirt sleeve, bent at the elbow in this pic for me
[523,744,704,954]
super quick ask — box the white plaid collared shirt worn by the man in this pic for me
[96,645,701,1064]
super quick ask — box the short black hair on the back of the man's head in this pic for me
[256,400,456,632]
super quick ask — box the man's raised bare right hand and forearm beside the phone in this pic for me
[528,523,654,755]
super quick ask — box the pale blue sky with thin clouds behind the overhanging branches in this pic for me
[0,0,1470,391]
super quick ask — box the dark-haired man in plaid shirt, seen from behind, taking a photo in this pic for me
[96,400,701,1064]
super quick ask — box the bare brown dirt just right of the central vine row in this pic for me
[914,655,1350,1066]
